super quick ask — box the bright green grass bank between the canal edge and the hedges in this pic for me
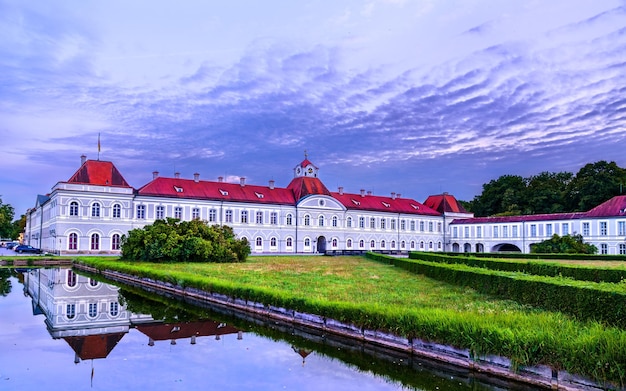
[81,257,626,387]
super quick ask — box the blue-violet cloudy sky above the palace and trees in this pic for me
[0,0,626,217]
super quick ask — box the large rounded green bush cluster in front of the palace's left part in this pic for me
[122,218,250,262]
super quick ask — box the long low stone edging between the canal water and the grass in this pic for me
[72,262,607,391]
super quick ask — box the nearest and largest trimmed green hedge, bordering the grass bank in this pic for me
[367,253,626,329]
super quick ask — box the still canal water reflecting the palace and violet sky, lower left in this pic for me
[0,268,536,391]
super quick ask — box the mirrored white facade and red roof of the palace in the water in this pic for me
[24,268,243,363]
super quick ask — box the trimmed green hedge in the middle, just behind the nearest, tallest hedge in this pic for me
[409,252,626,283]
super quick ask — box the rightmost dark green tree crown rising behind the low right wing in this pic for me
[567,160,626,211]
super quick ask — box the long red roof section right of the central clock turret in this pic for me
[331,193,440,216]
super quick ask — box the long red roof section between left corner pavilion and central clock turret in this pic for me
[137,177,295,205]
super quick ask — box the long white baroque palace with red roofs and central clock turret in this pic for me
[24,156,626,254]
